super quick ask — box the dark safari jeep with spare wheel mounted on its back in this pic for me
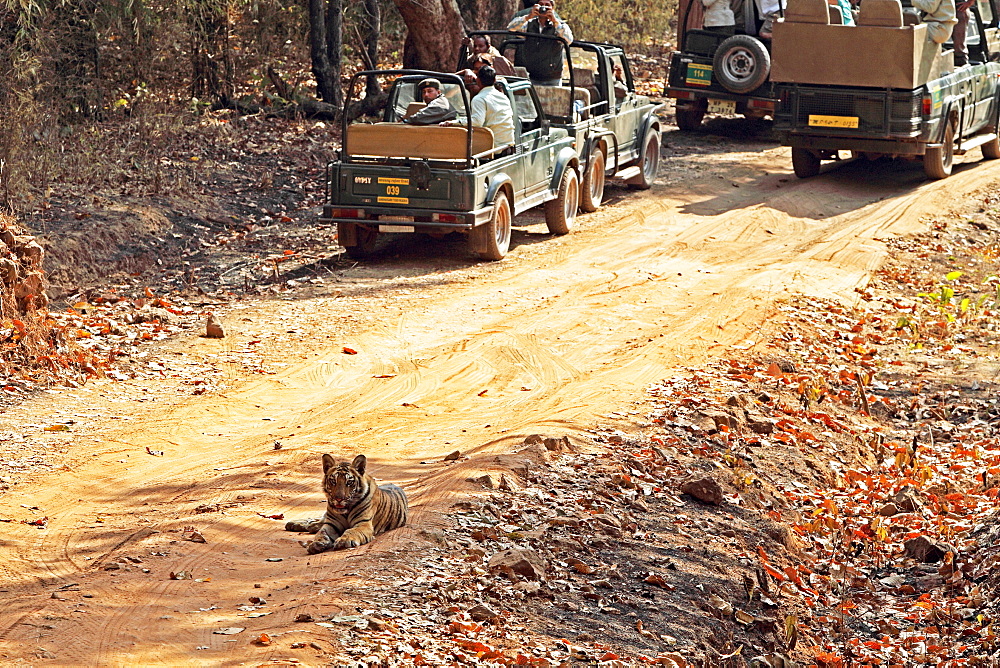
[664,0,775,131]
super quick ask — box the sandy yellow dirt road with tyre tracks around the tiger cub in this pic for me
[0,129,1000,665]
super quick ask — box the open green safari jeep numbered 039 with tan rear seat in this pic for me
[321,70,580,260]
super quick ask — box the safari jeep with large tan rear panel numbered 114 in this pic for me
[771,0,1000,179]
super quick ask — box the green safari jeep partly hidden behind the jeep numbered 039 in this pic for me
[482,30,662,213]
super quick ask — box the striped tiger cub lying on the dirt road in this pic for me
[285,455,409,554]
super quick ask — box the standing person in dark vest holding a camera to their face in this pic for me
[507,0,573,86]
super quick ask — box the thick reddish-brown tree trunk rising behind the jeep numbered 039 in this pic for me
[395,0,465,71]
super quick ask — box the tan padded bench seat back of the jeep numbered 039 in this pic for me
[345,123,493,160]
